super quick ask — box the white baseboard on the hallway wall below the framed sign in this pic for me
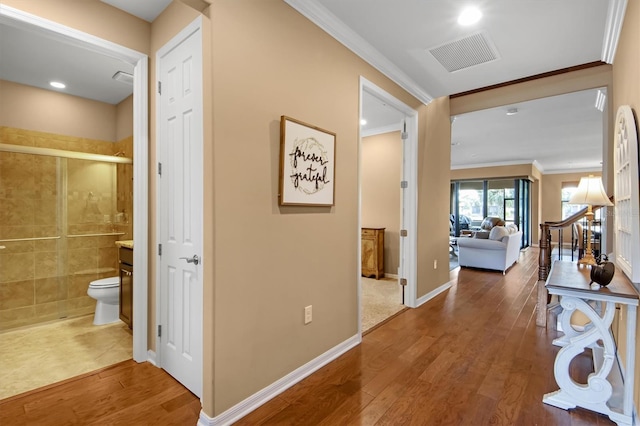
[198,335,362,426]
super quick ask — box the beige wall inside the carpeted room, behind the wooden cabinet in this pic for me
[360,131,402,275]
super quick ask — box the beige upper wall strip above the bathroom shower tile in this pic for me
[0,80,117,142]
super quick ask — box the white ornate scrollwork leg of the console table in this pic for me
[542,296,632,425]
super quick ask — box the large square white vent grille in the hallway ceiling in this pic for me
[429,33,499,72]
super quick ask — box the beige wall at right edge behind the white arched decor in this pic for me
[608,1,640,410]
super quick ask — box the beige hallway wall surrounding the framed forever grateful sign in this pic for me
[4,0,450,415]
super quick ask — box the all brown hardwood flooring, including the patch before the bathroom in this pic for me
[0,249,613,426]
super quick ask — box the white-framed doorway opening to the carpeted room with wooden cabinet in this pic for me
[358,78,417,332]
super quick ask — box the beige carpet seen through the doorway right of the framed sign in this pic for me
[360,277,404,332]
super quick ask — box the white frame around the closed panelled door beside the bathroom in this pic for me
[155,16,202,372]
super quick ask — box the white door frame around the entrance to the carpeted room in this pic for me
[357,76,418,335]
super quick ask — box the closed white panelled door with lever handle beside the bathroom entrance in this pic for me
[157,21,203,397]
